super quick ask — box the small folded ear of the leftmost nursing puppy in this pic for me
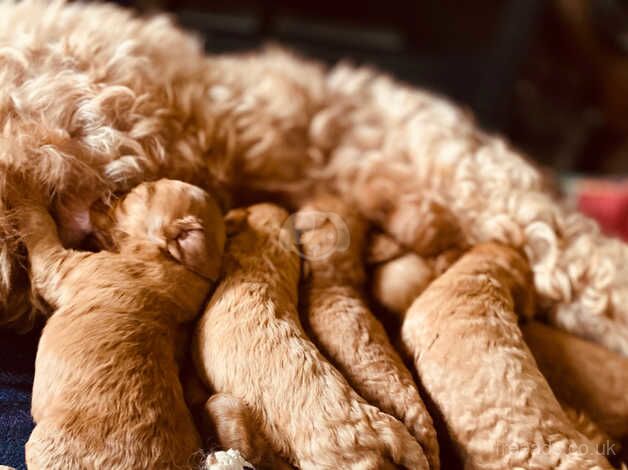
[166,217,222,281]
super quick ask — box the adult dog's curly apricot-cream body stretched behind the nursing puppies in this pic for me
[0,0,628,354]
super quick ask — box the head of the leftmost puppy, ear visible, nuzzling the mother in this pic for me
[90,179,225,280]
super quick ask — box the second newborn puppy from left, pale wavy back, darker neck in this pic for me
[193,204,427,470]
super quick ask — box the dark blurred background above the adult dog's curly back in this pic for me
[121,0,628,175]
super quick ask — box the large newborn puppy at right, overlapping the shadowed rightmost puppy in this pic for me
[402,244,611,470]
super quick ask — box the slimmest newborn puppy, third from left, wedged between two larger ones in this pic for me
[296,196,440,469]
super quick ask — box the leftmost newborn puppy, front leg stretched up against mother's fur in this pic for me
[19,180,225,470]
